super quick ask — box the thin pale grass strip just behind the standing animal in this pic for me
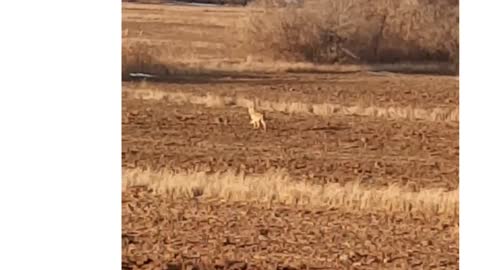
[129,89,459,122]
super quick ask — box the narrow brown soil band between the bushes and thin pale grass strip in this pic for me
[124,73,459,109]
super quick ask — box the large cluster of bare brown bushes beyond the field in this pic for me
[243,0,459,72]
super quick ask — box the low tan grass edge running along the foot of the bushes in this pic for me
[122,38,450,77]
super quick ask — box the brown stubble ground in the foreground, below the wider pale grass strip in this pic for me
[122,186,459,269]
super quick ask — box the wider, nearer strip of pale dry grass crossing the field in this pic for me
[122,169,459,218]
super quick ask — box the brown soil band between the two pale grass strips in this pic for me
[123,101,458,189]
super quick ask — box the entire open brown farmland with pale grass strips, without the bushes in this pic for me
[122,3,459,269]
